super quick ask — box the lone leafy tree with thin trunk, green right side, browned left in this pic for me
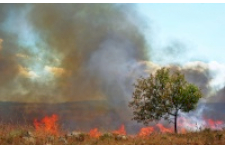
[129,67,202,133]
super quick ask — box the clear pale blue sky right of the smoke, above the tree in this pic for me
[137,3,225,64]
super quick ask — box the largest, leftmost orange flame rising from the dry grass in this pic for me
[34,114,58,135]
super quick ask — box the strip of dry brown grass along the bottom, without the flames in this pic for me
[0,124,225,145]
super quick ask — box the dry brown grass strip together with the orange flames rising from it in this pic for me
[0,114,225,145]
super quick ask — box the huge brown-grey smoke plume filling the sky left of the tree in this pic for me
[1,4,147,102]
